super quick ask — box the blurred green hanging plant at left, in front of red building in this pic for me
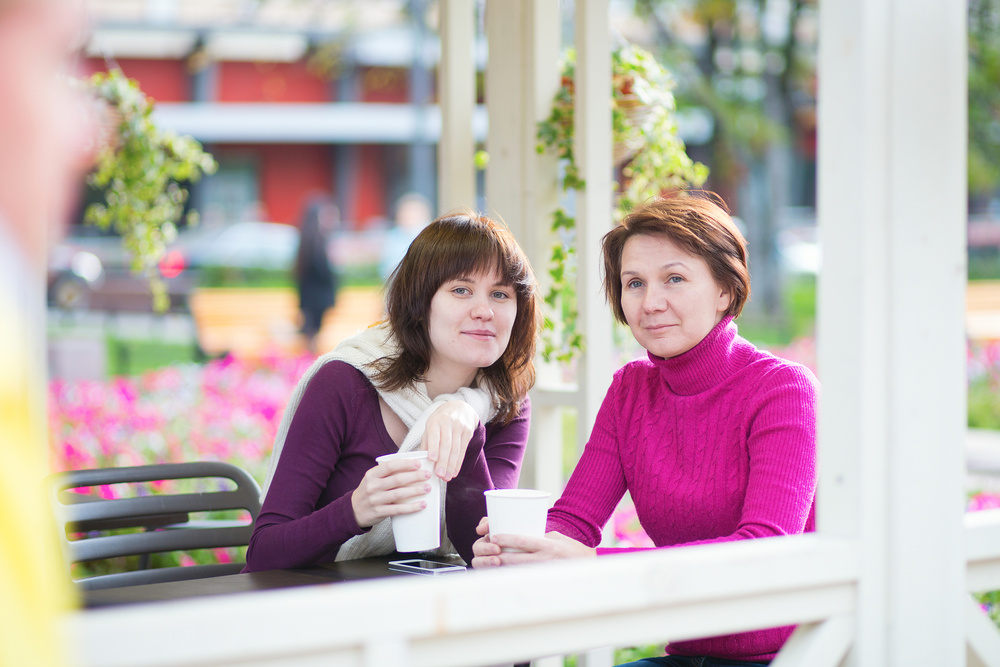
[84,68,217,312]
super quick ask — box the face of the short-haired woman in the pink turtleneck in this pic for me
[621,235,730,358]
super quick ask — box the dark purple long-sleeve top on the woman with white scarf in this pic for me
[244,361,531,572]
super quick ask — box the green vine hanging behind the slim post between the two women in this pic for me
[537,45,708,362]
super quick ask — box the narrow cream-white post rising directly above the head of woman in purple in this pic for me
[438,0,476,211]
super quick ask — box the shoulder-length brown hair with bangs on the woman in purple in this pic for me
[376,209,541,424]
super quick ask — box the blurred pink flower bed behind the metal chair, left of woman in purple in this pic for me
[49,348,312,493]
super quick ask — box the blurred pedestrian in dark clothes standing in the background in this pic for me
[295,198,340,354]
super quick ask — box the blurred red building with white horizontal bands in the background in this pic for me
[82,7,476,229]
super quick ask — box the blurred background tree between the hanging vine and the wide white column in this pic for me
[635,0,818,321]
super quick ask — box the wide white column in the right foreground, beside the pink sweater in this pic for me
[818,0,966,666]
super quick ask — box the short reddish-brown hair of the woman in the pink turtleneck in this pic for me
[602,192,750,324]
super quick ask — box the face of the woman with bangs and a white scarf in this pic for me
[428,270,517,386]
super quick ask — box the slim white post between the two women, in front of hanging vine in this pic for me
[574,0,614,448]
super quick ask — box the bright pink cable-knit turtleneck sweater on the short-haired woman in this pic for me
[548,317,818,661]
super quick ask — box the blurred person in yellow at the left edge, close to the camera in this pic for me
[0,0,94,667]
